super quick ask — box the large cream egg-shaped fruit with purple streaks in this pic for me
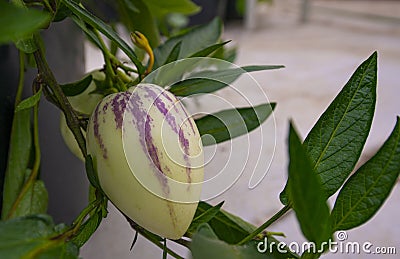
[87,84,204,239]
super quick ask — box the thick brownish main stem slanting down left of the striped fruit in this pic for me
[33,36,87,157]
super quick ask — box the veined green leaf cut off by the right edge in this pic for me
[332,117,400,231]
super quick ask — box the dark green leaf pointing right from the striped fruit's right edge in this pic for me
[195,103,275,146]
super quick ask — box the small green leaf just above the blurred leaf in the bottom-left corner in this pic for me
[11,180,48,218]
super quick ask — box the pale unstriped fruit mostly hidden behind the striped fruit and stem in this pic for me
[60,70,106,161]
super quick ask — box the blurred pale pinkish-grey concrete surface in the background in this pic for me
[81,0,400,259]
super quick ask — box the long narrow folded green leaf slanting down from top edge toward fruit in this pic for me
[62,0,145,73]
